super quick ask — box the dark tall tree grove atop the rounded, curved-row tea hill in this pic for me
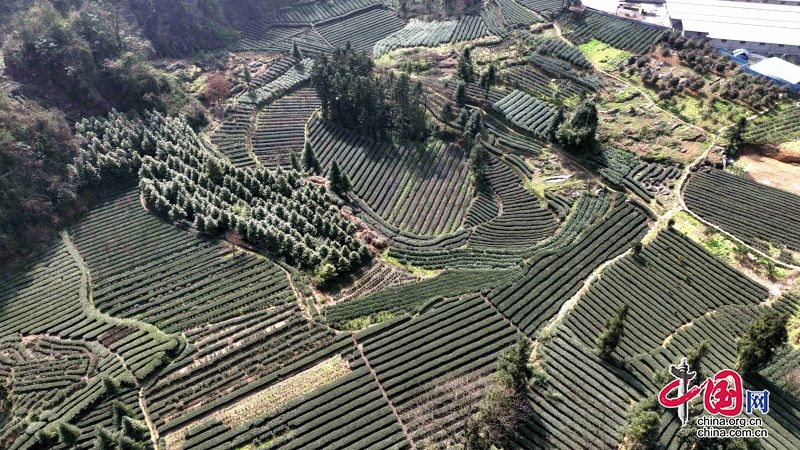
[311,45,428,143]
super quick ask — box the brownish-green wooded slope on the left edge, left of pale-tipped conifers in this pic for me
[0,93,79,274]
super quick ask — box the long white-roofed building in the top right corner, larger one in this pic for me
[666,0,800,55]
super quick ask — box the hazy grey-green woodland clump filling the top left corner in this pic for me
[3,1,196,115]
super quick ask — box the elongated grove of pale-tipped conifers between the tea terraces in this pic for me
[113,113,369,284]
